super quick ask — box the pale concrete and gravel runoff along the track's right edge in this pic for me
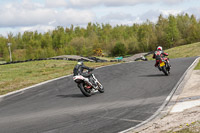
[128,57,200,133]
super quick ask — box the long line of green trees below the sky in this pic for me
[0,13,200,61]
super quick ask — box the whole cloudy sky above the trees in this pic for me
[0,0,200,36]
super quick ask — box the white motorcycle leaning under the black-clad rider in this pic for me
[73,71,104,97]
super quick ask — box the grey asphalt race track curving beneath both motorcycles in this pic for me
[0,58,196,133]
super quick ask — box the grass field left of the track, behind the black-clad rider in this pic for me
[0,60,116,95]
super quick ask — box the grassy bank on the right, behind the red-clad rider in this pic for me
[147,42,200,60]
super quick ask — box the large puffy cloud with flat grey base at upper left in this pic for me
[0,0,95,27]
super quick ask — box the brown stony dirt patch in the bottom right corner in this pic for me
[132,106,200,133]
